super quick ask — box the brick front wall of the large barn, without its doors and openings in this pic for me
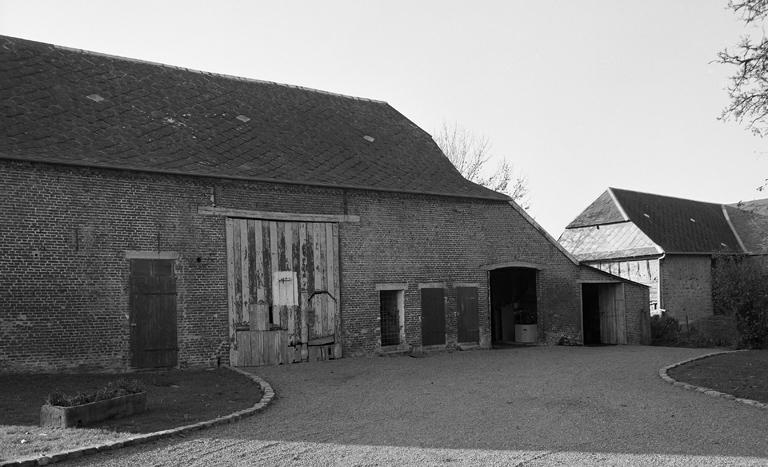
[0,162,640,371]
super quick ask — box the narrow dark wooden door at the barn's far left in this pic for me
[130,260,178,368]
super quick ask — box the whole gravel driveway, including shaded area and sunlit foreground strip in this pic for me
[64,346,768,467]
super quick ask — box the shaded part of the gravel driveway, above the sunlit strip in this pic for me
[223,346,768,458]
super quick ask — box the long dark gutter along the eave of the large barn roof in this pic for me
[0,155,511,202]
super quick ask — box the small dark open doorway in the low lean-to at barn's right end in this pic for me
[581,283,627,345]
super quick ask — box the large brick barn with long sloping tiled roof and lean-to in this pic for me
[0,36,648,371]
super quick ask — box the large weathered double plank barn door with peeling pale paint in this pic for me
[226,218,341,366]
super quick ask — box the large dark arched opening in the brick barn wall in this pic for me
[490,267,538,346]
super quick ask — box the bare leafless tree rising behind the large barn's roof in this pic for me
[434,120,532,209]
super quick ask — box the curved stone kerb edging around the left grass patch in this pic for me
[0,365,275,467]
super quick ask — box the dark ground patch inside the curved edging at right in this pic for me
[667,350,768,403]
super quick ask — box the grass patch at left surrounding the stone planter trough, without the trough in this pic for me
[0,369,262,461]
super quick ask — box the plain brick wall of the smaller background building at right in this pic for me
[660,255,713,322]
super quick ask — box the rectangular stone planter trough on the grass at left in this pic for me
[40,392,147,428]
